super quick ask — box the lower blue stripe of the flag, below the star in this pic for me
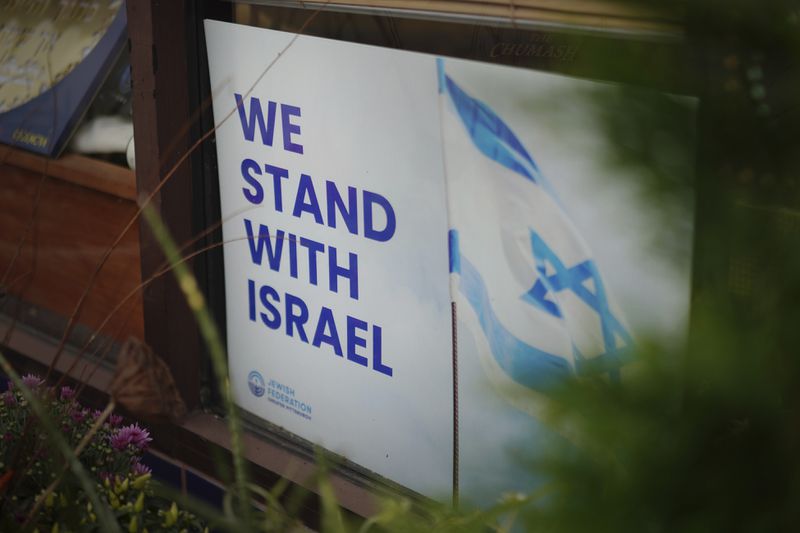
[460,256,572,392]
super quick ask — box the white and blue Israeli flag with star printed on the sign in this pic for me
[437,59,632,408]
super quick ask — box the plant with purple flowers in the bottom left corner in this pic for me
[0,374,203,532]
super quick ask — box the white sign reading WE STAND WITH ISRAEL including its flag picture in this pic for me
[206,21,690,499]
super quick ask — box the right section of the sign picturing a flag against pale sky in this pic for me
[437,59,692,501]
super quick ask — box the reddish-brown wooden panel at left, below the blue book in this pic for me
[0,145,144,340]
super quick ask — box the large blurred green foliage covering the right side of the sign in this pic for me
[344,0,800,533]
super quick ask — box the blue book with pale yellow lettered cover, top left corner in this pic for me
[0,1,127,157]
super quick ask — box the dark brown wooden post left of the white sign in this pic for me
[127,0,200,408]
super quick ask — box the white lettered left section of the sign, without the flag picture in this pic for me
[206,21,452,495]
